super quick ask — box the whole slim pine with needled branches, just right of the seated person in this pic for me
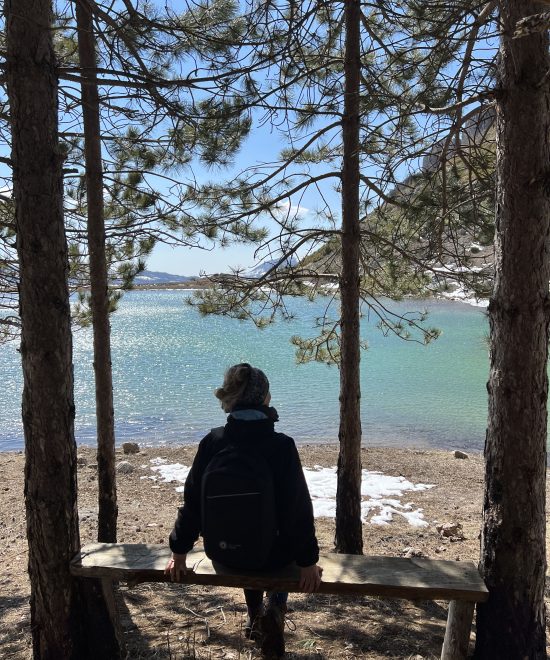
[191,0,444,553]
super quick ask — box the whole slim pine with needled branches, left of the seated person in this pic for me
[3,0,256,541]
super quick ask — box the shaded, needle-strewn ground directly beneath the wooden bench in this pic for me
[112,584,458,660]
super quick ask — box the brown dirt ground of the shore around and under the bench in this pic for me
[0,445,548,660]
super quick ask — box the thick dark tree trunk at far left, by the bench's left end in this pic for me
[4,0,122,660]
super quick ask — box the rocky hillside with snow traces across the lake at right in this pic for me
[300,110,494,302]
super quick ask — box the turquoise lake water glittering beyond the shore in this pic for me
[0,290,489,451]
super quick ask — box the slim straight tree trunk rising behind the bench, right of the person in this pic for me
[335,0,363,554]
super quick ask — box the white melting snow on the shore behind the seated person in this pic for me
[147,458,433,527]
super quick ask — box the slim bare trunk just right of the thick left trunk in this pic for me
[76,0,118,543]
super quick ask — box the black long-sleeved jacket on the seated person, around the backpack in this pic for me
[170,409,319,568]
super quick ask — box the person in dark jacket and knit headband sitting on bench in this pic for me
[166,363,322,658]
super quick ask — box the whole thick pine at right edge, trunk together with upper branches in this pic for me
[386,0,550,648]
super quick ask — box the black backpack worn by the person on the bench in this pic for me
[201,429,278,570]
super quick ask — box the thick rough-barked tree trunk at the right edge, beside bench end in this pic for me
[476,0,550,660]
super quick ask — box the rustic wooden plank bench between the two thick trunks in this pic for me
[71,543,489,660]
